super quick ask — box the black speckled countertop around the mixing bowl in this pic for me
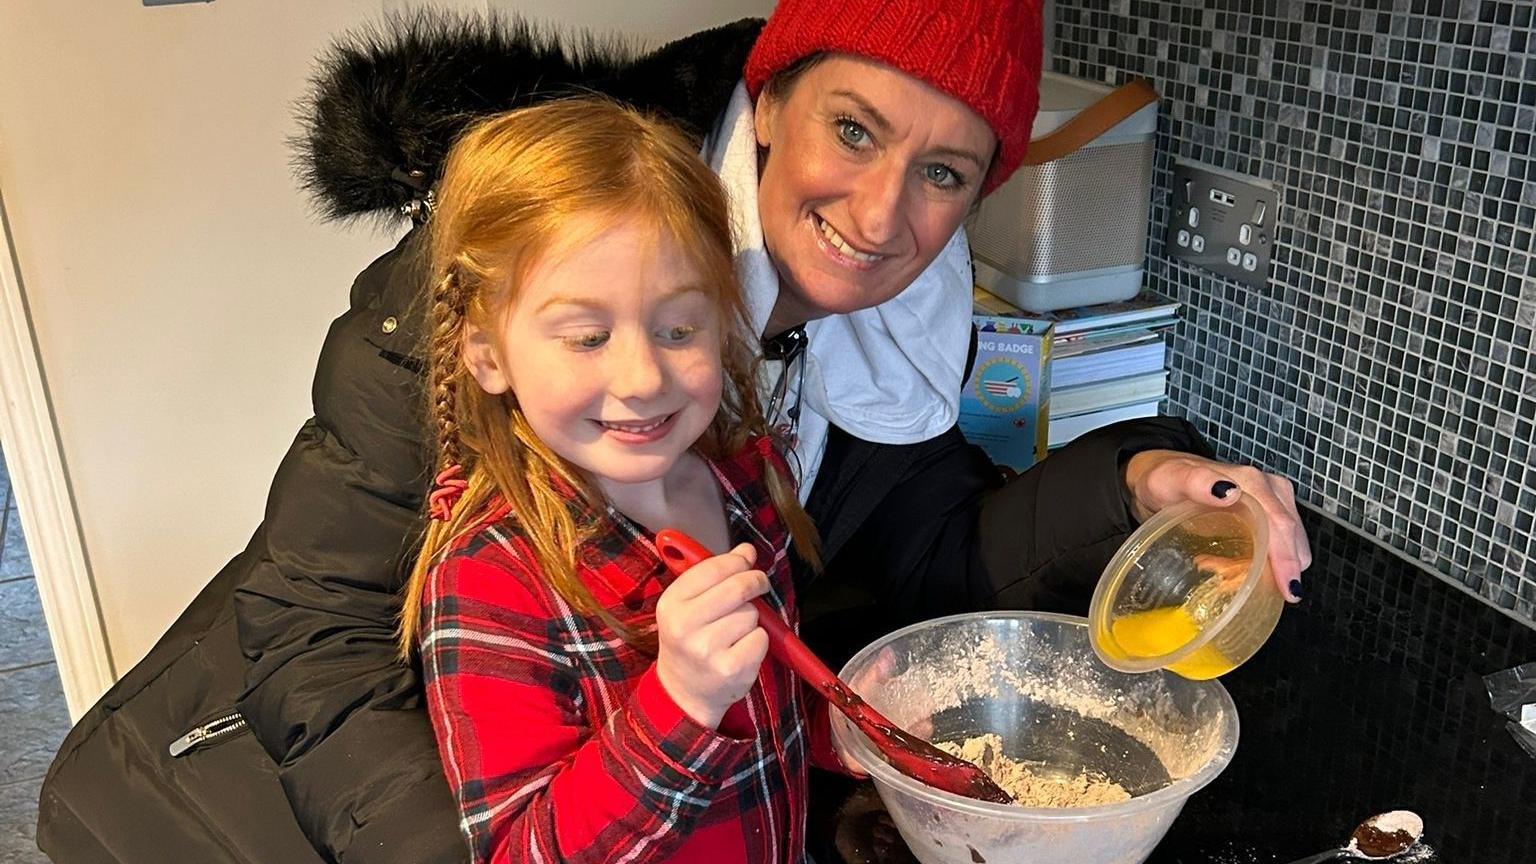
[811,510,1536,864]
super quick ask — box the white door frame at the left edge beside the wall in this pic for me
[0,189,117,723]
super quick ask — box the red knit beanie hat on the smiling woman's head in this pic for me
[746,0,1040,195]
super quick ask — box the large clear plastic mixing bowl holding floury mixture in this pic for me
[833,612,1238,864]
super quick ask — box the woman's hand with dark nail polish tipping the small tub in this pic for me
[1126,450,1312,603]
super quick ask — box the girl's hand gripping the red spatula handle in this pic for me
[656,543,768,729]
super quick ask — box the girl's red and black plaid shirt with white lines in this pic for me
[421,446,840,864]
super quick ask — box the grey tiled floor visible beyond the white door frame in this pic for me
[0,460,69,864]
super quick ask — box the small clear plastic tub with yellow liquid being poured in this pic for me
[1087,497,1286,681]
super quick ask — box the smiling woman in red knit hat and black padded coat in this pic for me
[38,0,1310,864]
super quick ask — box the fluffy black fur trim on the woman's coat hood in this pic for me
[293,11,762,221]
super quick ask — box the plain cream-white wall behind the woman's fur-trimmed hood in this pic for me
[0,0,773,673]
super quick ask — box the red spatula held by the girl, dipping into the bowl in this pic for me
[656,530,1014,804]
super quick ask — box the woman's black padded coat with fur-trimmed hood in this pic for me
[37,13,1204,864]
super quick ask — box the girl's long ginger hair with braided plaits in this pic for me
[399,98,820,658]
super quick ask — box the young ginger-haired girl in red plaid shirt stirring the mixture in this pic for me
[402,100,837,864]
